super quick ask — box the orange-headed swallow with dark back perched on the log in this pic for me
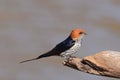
[20,29,86,63]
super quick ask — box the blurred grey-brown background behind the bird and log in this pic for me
[0,0,120,80]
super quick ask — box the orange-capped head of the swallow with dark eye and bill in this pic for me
[70,29,86,40]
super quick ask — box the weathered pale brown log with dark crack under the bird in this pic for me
[64,51,120,78]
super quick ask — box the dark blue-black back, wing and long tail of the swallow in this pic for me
[20,36,75,63]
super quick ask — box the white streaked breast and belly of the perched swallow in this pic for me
[61,43,81,55]
